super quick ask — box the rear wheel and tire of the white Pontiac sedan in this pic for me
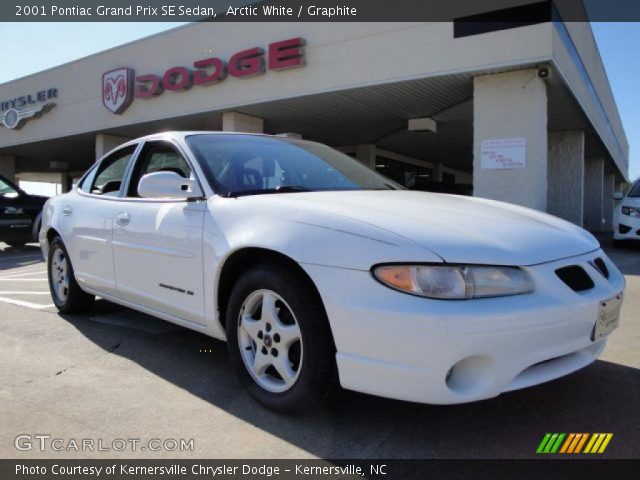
[47,237,95,313]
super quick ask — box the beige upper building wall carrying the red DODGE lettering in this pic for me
[0,22,552,148]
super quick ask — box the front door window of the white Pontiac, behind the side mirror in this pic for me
[127,142,191,197]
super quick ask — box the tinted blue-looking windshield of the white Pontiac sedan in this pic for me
[186,134,403,197]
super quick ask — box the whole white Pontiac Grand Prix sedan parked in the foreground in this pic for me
[40,132,624,411]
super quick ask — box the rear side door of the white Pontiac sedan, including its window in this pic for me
[58,145,136,296]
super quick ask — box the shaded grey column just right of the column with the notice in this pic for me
[547,130,584,227]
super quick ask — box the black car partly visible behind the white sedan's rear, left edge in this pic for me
[0,175,47,247]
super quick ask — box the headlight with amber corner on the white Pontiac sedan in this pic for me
[372,265,533,300]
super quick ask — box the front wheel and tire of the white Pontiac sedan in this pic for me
[226,263,336,413]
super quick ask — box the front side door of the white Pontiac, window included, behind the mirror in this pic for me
[113,141,206,324]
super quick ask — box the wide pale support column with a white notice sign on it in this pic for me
[473,69,547,211]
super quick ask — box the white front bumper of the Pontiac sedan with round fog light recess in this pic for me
[303,250,624,404]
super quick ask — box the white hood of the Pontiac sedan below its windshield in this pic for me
[243,190,600,265]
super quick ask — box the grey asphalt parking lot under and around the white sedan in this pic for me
[0,240,640,458]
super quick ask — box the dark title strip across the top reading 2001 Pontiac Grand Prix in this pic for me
[0,0,640,24]
